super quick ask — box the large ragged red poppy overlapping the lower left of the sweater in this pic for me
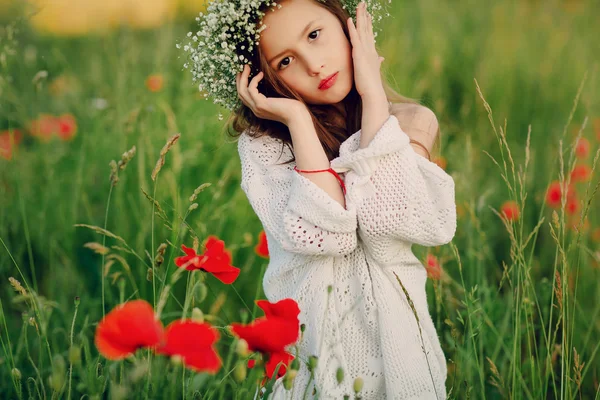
[231,298,300,379]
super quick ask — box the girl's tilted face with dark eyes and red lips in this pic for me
[259,0,354,104]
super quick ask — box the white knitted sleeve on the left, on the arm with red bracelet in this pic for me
[238,133,358,256]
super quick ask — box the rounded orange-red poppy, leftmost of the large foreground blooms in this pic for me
[94,300,164,360]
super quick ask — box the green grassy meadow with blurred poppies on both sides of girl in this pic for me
[0,0,600,399]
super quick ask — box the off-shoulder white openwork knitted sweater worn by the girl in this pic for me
[238,115,456,400]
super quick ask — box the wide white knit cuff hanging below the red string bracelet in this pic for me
[288,171,358,233]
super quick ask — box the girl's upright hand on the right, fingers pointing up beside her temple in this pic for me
[346,2,384,98]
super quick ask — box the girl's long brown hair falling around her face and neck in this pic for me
[226,0,426,164]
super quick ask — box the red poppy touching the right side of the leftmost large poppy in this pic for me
[156,320,222,374]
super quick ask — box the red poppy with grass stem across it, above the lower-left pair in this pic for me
[175,235,240,284]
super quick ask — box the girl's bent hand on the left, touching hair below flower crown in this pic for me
[235,64,308,125]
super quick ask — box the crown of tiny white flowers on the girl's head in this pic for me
[177,0,391,120]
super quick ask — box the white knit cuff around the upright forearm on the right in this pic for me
[331,114,410,176]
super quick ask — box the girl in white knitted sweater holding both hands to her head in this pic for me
[233,0,456,400]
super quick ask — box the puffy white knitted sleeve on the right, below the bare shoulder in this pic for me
[331,115,456,246]
